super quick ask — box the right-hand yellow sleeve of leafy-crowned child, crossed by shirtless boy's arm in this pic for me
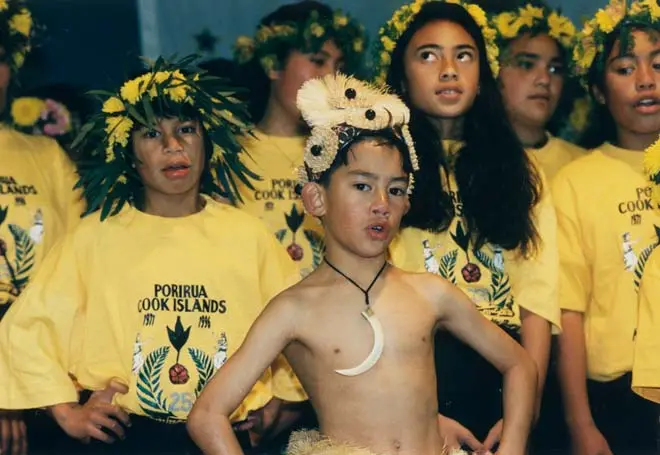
[259,229,307,401]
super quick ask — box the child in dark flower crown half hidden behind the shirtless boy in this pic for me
[236,0,365,282]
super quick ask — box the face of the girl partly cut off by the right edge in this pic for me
[595,31,660,139]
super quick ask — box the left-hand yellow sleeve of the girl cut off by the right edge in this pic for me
[552,172,592,313]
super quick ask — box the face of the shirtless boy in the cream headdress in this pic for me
[314,140,409,258]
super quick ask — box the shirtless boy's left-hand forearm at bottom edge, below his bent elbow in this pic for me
[187,410,243,455]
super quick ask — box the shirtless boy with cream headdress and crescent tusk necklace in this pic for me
[188,75,536,455]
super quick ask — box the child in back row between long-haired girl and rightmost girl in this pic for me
[493,3,586,180]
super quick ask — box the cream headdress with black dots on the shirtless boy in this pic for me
[296,74,419,194]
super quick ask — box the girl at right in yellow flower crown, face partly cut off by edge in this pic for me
[552,0,660,454]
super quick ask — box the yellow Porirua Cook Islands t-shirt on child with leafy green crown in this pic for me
[0,200,304,422]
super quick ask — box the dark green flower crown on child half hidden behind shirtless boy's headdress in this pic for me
[234,10,366,73]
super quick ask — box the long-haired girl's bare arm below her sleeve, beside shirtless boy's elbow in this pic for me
[521,309,551,421]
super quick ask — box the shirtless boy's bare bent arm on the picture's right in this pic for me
[433,277,537,455]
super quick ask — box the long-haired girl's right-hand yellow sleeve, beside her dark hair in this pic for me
[508,171,561,332]
